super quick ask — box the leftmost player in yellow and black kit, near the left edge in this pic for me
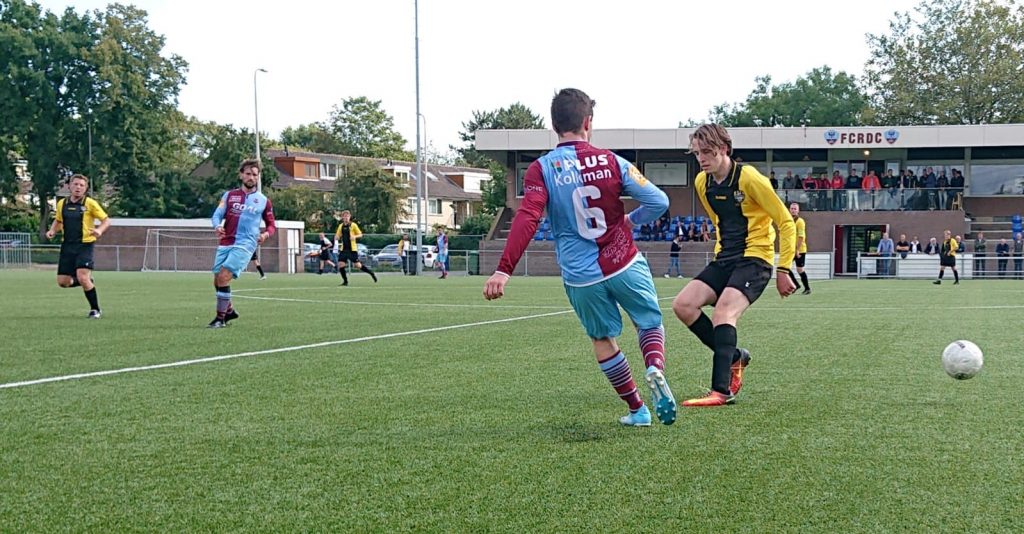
[46,174,111,319]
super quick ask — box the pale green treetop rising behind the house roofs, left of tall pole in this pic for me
[326,96,415,161]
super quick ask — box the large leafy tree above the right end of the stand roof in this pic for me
[865,0,1024,124]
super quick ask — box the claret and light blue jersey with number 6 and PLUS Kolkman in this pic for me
[497,141,669,287]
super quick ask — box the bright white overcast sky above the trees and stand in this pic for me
[40,0,920,156]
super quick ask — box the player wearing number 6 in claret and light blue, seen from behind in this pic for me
[483,89,675,426]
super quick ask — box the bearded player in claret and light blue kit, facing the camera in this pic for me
[207,155,278,328]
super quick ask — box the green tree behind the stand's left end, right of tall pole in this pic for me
[455,102,545,215]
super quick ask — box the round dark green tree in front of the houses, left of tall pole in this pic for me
[333,160,409,234]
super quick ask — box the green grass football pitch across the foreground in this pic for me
[0,271,1024,532]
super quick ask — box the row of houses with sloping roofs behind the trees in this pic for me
[266,150,490,233]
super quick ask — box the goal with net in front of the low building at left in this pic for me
[142,229,220,272]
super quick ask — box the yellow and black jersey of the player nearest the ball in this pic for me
[694,162,797,272]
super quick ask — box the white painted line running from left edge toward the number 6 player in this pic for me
[0,310,572,389]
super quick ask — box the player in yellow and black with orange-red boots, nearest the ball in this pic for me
[672,124,797,406]
